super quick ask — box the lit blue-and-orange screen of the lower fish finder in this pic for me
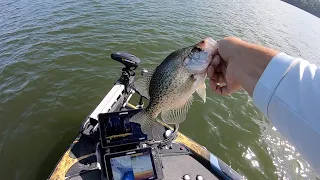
[110,152,155,180]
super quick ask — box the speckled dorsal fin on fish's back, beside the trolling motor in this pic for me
[134,70,154,99]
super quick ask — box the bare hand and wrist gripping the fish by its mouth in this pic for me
[207,37,277,96]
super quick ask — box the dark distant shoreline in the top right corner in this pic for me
[281,0,320,18]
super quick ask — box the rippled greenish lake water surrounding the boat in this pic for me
[0,0,320,179]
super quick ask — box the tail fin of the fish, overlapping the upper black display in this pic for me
[129,109,156,137]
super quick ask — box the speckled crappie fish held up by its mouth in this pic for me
[130,38,216,134]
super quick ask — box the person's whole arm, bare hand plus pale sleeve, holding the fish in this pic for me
[215,37,320,173]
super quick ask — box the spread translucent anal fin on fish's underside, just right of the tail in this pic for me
[161,95,193,124]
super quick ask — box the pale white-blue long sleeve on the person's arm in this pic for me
[253,53,320,174]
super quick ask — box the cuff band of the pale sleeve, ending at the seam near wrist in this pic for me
[252,53,297,117]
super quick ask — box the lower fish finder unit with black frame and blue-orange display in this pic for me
[104,148,160,180]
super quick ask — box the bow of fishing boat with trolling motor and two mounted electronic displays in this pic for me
[48,52,244,180]
